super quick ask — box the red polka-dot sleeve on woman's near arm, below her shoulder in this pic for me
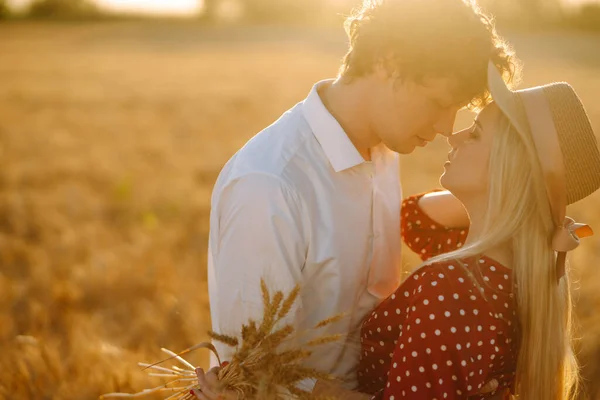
[383,270,500,400]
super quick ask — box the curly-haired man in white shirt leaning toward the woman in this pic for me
[208,0,514,396]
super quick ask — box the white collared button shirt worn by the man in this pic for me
[208,81,401,387]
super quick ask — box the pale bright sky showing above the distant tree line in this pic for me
[8,0,600,15]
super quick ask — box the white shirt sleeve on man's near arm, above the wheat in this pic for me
[208,174,308,366]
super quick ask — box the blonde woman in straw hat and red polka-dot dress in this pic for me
[196,64,600,400]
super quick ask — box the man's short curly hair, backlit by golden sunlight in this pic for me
[339,0,520,109]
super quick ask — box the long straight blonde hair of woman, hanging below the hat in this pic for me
[427,110,578,400]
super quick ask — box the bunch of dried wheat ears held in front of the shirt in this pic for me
[101,280,343,400]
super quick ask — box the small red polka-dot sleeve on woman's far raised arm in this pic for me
[401,192,469,261]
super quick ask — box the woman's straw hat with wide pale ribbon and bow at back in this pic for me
[488,62,600,279]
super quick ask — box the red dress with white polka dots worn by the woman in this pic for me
[357,195,519,400]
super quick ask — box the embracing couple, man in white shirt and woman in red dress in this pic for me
[194,0,600,400]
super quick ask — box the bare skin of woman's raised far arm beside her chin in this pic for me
[419,190,470,228]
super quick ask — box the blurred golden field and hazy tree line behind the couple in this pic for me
[0,0,600,400]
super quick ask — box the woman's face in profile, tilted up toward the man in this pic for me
[440,103,502,198]
